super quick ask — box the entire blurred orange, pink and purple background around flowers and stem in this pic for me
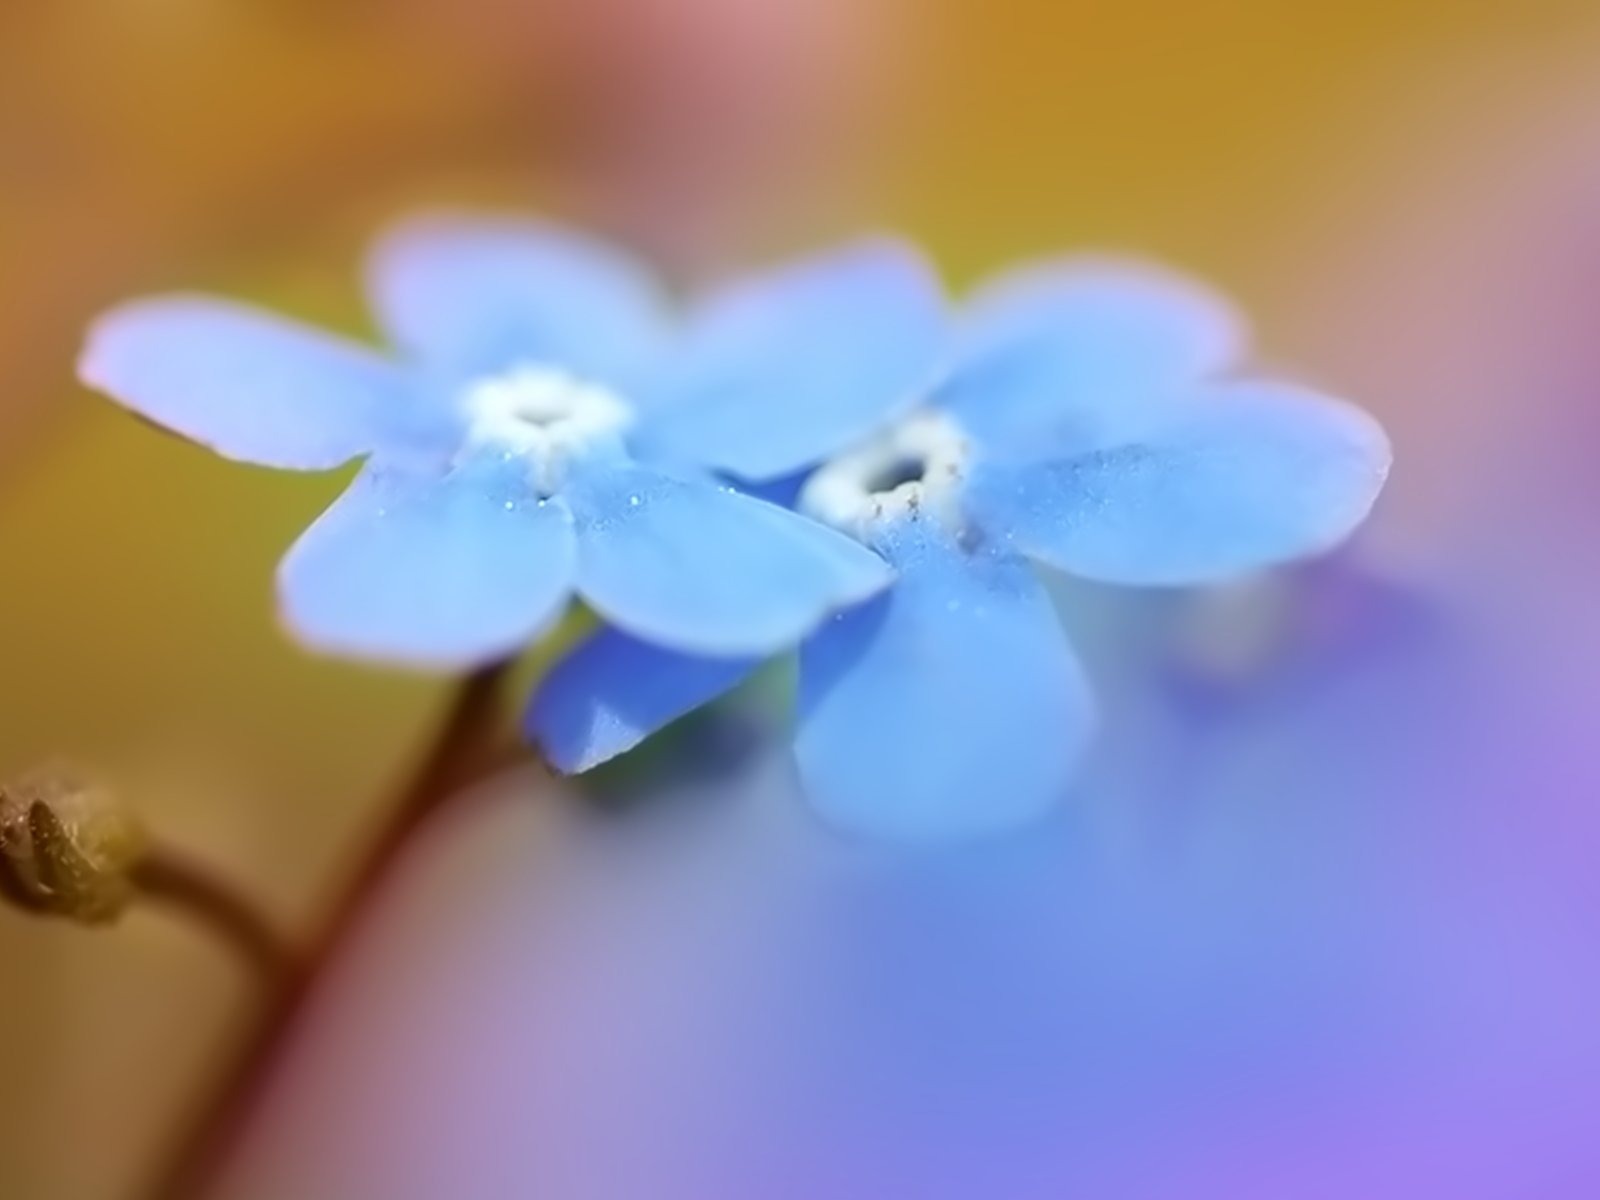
[0,0,1600,1200]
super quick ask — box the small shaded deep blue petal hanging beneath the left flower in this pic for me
[525,629,762,774]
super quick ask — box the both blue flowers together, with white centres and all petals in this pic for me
[82,216,1389,838]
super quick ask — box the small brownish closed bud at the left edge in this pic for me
[0,766,147,925]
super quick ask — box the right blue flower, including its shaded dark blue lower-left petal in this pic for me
[528,245,1389,838]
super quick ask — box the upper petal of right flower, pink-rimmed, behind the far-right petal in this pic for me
[936,258,1250,448]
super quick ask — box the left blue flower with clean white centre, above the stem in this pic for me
[80,216,915,667]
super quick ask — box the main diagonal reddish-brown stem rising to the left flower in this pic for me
[144,664,521,1200]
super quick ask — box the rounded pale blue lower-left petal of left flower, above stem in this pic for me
[278,461,576,669]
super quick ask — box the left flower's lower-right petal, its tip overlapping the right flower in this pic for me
[568,461,890,656]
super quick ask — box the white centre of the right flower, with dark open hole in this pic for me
[800,411,970,539]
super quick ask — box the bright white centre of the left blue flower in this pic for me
[461,365,634,496]
